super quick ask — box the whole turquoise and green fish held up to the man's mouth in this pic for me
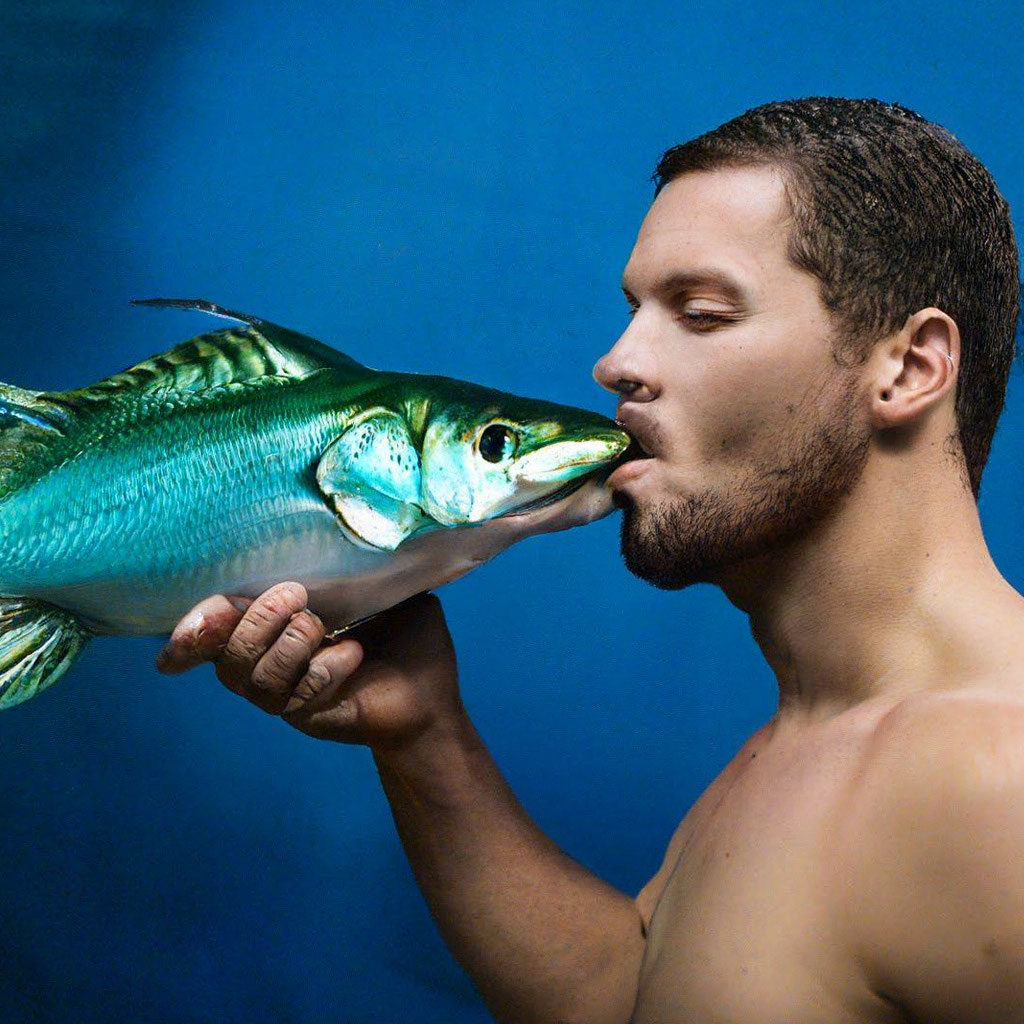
[0,299,631,710]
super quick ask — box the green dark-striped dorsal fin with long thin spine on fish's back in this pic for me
[44,299,367,404]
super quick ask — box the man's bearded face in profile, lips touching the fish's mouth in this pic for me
[594,167,870,589]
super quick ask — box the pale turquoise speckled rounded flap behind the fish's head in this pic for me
[316,409,433,551]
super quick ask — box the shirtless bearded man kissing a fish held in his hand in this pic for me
[155,99,1024,1024]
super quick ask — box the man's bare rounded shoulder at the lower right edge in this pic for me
[846,684,1024,1024]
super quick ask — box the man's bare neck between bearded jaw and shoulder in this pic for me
[719,456,1024,719]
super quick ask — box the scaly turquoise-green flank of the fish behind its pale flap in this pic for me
[0,372,387,633]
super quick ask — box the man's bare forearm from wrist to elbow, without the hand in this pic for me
[375,718,644,1024]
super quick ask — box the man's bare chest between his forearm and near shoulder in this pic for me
[634,724,898,1024]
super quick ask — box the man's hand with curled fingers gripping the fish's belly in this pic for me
[158,583,462,750]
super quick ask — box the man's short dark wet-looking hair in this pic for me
[654,96,1020,498]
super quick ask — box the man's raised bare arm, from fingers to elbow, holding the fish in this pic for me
[161,584,644,1024]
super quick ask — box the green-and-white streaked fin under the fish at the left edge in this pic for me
[0,597,92,711]
